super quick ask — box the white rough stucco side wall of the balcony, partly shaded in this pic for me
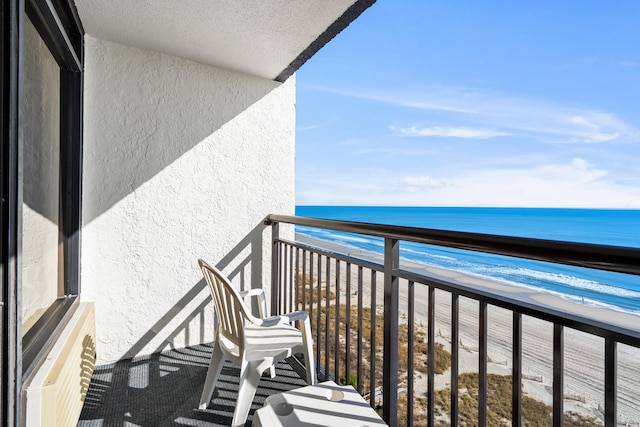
[81,36,295,363]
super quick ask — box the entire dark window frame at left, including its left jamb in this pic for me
[0,0,84,426]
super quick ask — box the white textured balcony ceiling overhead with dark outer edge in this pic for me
[76,0,375,81]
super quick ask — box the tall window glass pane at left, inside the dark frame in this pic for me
[22,19,64,335]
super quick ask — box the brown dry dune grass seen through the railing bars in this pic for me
[298,275,603,427]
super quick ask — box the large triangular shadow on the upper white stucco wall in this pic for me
[24,37,281,224]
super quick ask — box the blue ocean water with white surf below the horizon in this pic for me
[296,206,640,314]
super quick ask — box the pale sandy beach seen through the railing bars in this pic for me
[297,236,640,426]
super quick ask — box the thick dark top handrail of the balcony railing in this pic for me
[266,214,640,276]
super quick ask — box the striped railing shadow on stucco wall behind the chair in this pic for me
[123,224,265,359]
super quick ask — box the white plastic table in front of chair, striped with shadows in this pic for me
[253,381,387,427]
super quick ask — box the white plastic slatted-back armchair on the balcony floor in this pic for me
[198,260,317,426]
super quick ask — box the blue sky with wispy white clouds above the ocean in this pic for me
[296,0,640,208]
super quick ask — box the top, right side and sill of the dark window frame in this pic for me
[22,0,84,383]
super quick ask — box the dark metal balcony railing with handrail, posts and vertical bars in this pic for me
[265,214,640,427]
